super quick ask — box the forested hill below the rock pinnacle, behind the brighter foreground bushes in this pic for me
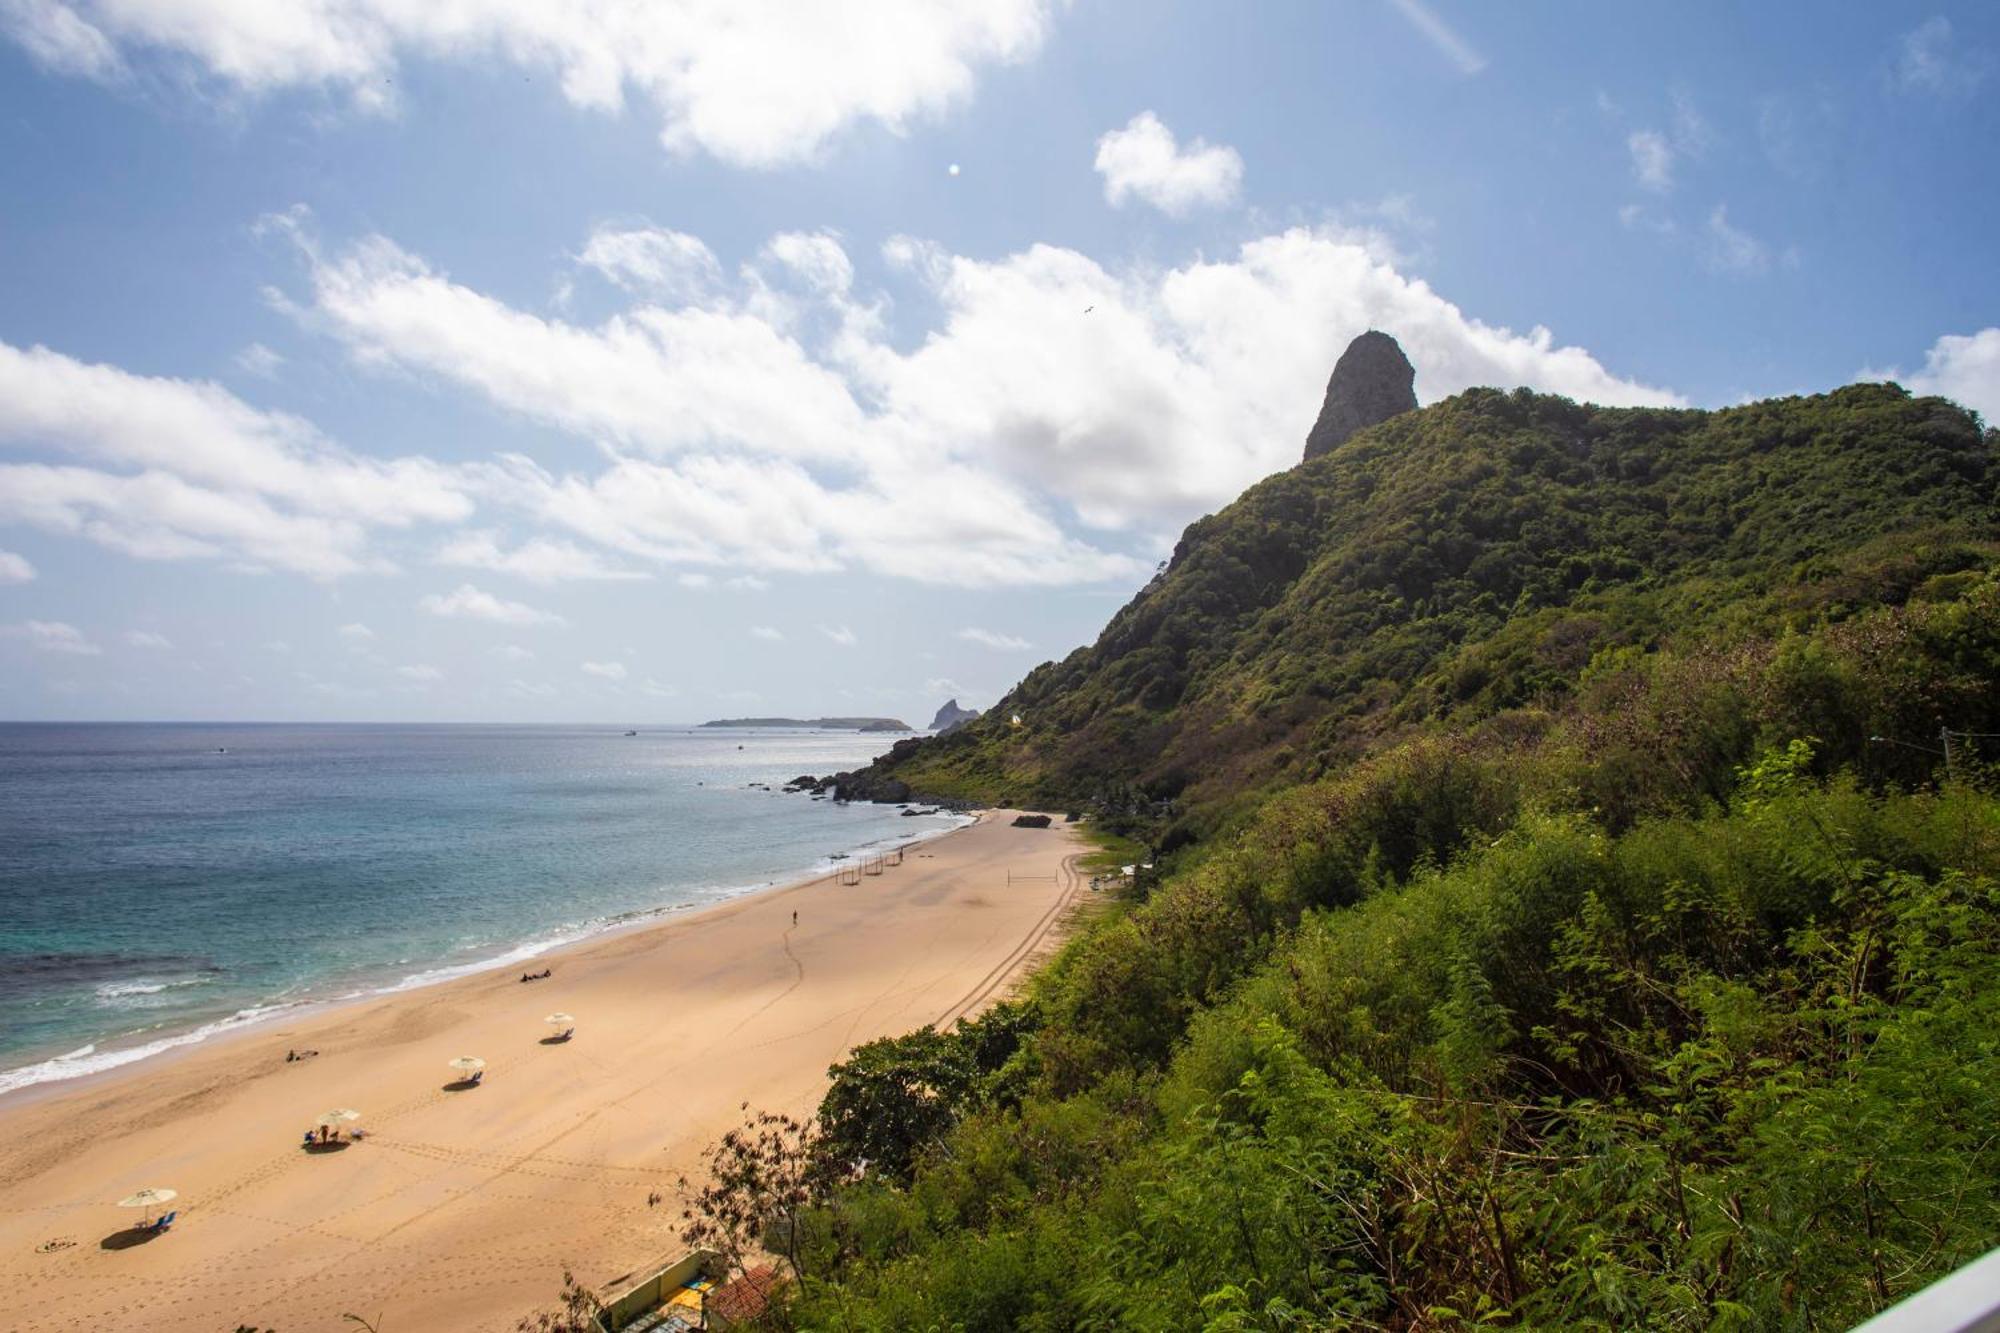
[866,370,2000,809]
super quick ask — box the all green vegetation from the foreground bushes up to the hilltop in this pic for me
[660,386,2000,1329]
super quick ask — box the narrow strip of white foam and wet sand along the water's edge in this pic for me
[0,811,984,1115]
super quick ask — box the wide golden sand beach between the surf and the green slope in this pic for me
[0,811,1080,1333]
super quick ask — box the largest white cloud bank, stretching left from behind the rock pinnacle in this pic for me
[282,219,1678,586]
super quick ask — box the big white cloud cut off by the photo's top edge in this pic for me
[0,0,1050,168]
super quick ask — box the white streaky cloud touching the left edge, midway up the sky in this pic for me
[0,342,472,578]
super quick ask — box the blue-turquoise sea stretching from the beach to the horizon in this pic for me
[0,723,958,1093]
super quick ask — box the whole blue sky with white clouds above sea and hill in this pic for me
[0,0,2000,725]
